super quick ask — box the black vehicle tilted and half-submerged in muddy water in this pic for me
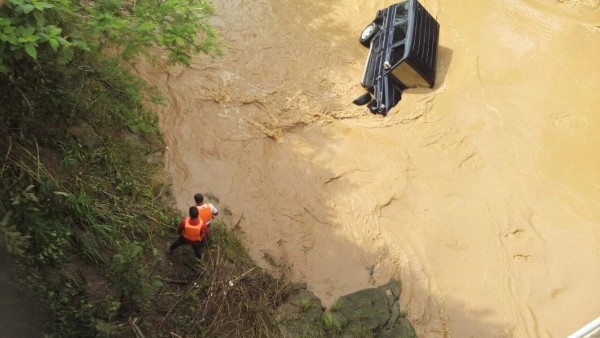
[354,0,440,115]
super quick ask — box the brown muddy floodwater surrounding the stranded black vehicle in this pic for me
[139,0,600,337]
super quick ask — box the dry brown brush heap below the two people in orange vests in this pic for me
[156,222,290,337]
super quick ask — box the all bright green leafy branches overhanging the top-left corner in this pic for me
[0,0,219,74]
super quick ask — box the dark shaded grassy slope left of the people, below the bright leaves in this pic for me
[0,59,174,337]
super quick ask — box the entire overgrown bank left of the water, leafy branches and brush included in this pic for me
[0,0,286,337]
